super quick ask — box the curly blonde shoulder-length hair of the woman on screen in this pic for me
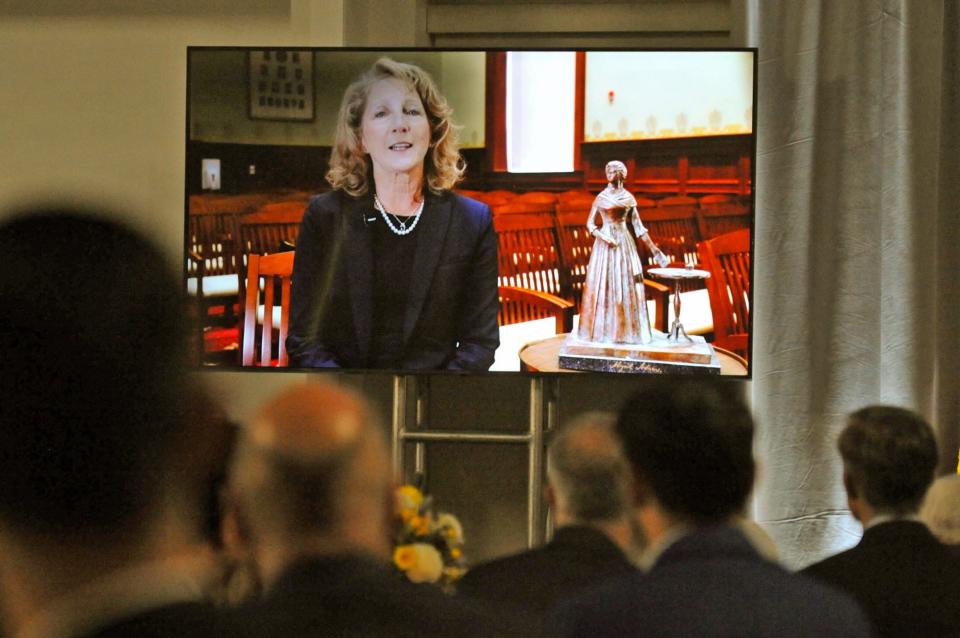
[326,58,466,197]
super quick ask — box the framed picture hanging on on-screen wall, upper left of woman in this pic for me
[247,49,314,122]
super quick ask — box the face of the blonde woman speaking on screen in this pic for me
[360,78,430,184]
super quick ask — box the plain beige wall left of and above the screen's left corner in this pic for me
[0,0,342,259]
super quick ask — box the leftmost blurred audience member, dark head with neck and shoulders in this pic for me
[0,208,223,636]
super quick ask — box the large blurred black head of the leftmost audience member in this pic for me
[0,210,186,541]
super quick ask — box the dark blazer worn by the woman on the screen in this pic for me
[287,191,500,370]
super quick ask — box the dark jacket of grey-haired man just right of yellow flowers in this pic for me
[457,525,635,617]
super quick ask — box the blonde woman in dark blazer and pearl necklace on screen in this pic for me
[287,58,499,370]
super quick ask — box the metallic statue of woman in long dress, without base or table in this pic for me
[577,160,669,343]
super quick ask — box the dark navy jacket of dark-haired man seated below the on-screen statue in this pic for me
[547,526,872,638]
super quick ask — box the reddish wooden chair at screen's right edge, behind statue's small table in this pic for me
[698,229,750,358]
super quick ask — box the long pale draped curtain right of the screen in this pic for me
[751,0,960,567]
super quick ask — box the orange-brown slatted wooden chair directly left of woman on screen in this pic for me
[241,252,294,367]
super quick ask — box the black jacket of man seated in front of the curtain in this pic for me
[803,521,960,636]
